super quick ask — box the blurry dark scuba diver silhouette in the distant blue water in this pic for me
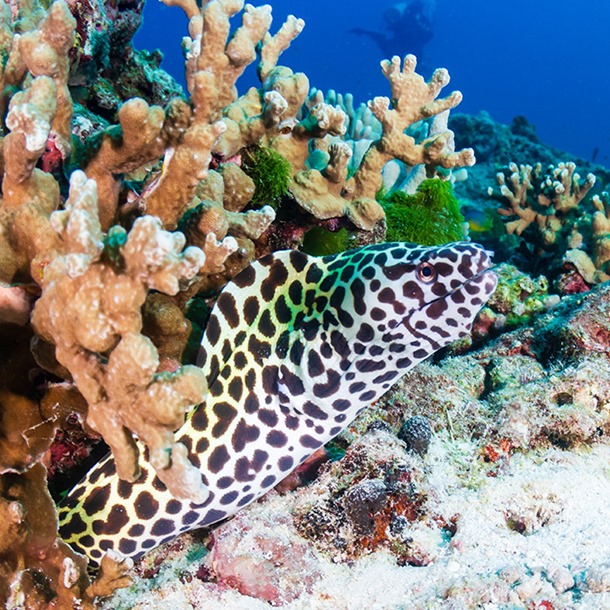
[350,0,434,62]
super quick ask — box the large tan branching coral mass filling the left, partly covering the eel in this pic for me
[0,0,474,609]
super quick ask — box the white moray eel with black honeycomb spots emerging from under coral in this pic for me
[59,242,497,563]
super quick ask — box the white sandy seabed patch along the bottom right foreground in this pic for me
[104,438,610,610]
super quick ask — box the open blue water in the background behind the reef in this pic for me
[135,0,610,165]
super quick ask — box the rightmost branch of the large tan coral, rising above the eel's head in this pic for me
[291,55,474,230]
